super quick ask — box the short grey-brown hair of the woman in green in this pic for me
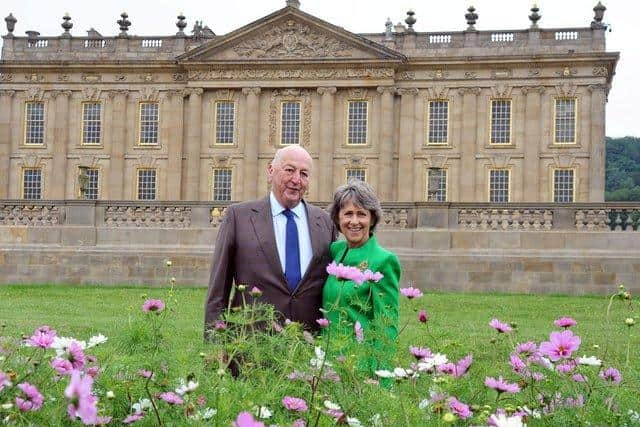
[329,179,382,235]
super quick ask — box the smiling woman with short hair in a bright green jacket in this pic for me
[322,180,401,369]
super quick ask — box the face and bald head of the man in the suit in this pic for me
[267,150,311,209]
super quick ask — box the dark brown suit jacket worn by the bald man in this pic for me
[204,196,337,332]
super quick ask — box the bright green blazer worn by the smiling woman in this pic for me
[322,236,401,345]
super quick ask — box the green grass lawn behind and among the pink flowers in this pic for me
[0,286,640,425]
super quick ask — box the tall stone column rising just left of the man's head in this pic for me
[240,87,262,200]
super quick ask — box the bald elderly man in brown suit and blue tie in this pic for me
[204,145,337,332]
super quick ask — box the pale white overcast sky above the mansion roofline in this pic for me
[0,0,640,137]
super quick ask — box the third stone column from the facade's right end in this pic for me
[459,87,481,202]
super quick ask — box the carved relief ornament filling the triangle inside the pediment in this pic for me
[233,19,353,58]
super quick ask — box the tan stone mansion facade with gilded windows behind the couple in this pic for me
[0,3,618,204]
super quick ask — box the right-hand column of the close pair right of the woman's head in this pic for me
[396,88,418,202]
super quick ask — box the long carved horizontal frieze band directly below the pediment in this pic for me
[188,68,395,80]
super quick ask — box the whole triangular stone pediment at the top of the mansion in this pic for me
[178,7,406,63]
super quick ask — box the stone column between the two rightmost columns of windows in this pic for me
[522,86,544,202]
